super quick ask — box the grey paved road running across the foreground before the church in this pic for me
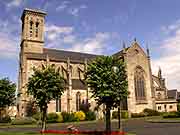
[0,120,180,135]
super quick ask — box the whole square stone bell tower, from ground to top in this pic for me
[17,9,46,116]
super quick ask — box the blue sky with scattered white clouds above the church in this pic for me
[0,0,180,89]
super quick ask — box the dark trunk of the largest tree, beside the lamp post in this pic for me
[106,104,111,135]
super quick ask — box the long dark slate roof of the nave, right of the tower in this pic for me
[26,48,100,63]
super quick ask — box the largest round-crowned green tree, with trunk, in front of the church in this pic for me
[86,56,128,132]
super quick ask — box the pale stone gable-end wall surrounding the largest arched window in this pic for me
[125,42,153,113]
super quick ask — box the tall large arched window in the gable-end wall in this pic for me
[134,66,146,100]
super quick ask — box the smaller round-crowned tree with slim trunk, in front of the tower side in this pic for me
[27,65,65,131]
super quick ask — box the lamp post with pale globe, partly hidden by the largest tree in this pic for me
[113,66,122,131]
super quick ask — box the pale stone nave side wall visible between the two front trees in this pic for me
[26,60,95,112]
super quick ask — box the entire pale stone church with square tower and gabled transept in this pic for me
[18,9,177,116]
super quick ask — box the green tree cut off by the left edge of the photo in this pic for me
[0,78,16,120]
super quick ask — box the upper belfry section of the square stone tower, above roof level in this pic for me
[21,8,46,53]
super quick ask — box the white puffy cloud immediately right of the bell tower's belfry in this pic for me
[45,24,73,41]
